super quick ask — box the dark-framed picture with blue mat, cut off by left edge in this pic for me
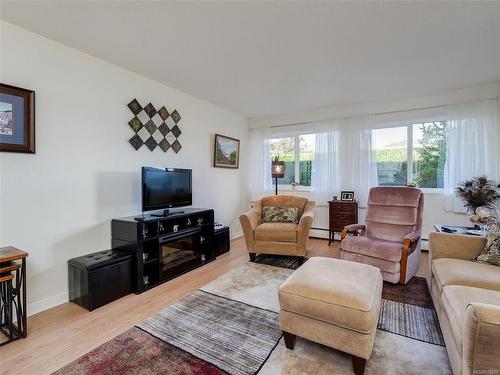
[0,83,35,154]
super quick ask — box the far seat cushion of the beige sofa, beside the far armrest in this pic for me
[432,258,500,291]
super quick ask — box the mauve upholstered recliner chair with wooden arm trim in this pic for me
[340,187,424,284]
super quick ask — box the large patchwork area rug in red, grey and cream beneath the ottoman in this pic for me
[57,263,451,375]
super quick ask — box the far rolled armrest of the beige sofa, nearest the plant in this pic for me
[429,232,486,260]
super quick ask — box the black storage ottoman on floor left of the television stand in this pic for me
[68,250,132,311]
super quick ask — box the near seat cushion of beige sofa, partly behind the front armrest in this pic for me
[441,285,500,351]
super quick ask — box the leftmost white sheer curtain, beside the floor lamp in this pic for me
[249,128,273,201]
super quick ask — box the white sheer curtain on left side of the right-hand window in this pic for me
[340,116,378,207]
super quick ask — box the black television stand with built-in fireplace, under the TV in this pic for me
[111,208,229,293]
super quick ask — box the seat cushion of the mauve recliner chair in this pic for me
[340,236,403,262]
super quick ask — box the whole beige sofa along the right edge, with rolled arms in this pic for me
[429,233,500,375]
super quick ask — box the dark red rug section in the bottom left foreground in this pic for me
[54,327,226,375]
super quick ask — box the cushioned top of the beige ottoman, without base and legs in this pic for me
[278,257,382,333]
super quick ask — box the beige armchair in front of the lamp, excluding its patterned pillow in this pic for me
[240,195,314,261]
